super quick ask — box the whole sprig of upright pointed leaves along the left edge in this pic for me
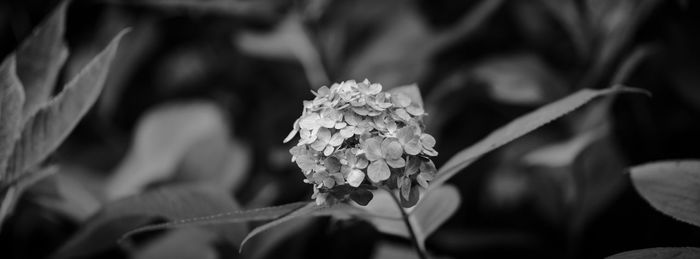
[0,2,127,232]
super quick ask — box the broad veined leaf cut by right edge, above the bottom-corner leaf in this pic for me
[630,160,700,226]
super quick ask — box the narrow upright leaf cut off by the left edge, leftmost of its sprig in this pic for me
[0,55,24,178]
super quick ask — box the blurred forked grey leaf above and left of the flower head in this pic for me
[234,12,330,88]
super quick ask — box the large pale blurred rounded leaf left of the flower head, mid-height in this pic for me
[106,102,250,199]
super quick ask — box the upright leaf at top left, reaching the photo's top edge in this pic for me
[16,0,70,119]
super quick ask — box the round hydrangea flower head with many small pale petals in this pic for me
[284,79,437,206]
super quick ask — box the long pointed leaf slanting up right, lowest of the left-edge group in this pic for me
[8,29,128,179]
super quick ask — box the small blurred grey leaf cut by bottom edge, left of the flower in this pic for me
[133,228,218,259]
